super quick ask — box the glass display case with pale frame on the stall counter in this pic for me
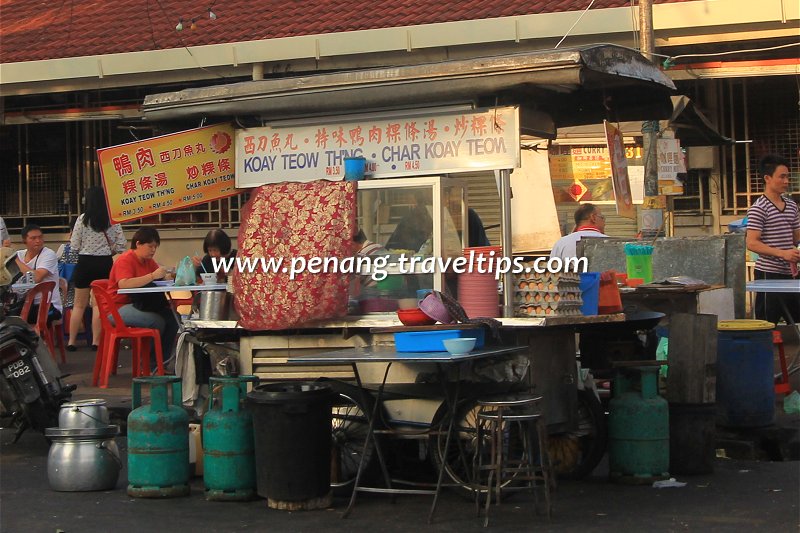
[351,176,468,314]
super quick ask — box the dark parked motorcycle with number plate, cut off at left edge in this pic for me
[0,248,76,442]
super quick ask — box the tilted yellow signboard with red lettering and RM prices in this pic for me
[97,124,239,222]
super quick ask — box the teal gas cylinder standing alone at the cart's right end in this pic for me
[608,366,669,482]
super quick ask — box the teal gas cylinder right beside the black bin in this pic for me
[203,376,258,501]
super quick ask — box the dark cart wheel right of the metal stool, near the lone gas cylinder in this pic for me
[548,390,608,479]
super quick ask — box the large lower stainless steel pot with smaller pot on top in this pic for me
[45,426,122,492]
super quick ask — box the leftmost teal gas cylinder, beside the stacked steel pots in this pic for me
[128,376,189,498]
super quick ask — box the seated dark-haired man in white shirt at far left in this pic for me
[16,224,62,324]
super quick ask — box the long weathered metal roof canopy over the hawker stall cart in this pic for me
[143,45,675,137]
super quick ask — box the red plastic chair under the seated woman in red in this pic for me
[91,280,164,389]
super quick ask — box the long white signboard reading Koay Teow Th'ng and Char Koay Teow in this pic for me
[236,107,519,187]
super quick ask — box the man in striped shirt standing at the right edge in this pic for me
[747,155,800,323]
